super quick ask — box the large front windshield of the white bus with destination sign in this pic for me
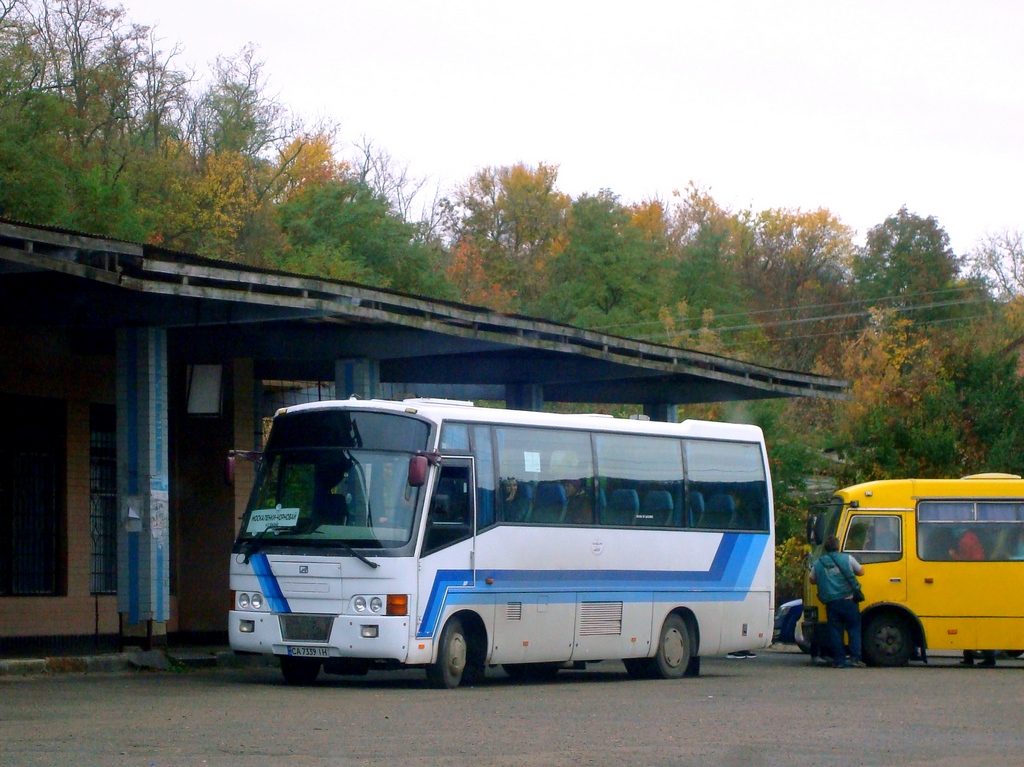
[239,411,429,549]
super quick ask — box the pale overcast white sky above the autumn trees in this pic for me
[116,0,1024,255]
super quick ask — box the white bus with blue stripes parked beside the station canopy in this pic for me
[228,399,775,688]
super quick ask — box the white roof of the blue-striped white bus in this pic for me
[278,398,764,442]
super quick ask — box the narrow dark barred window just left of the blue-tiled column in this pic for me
[89,404,118,594]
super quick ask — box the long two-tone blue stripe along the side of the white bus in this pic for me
[416,532,768,639]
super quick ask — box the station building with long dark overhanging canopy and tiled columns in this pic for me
[0,219,845,656]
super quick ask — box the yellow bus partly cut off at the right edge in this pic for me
[803,474,1024,666]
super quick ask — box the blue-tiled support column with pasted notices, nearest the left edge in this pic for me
[117,328,170,647]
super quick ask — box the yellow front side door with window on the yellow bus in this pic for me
[843,511,907,606]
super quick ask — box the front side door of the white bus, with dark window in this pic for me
[417,456,476,636]
